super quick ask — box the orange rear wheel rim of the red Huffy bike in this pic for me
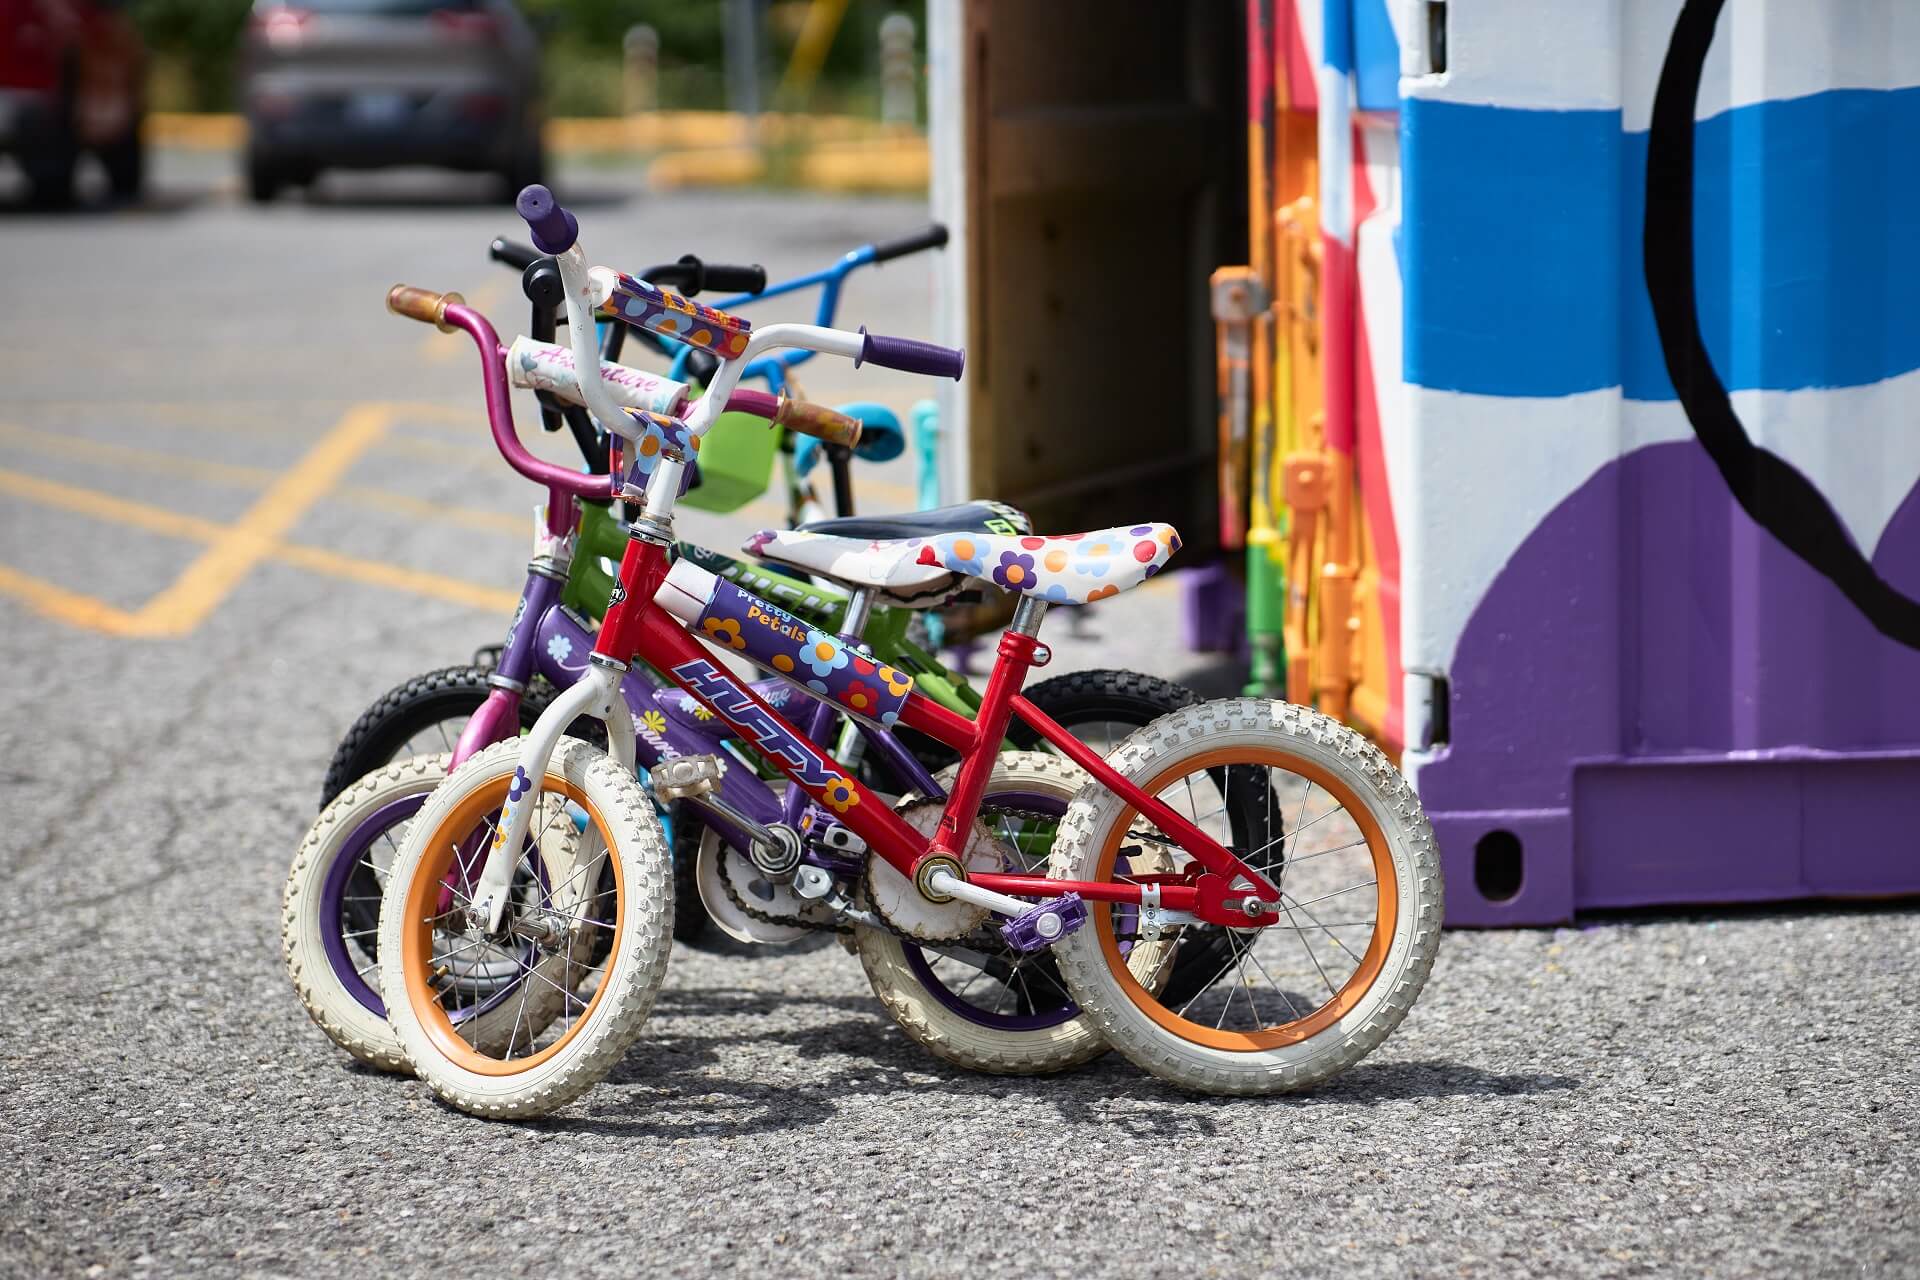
[1091,747,1400,1054]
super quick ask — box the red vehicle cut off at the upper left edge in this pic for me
[0,0,146,205]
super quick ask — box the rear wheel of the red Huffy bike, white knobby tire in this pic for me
[1050,699,1442,1094]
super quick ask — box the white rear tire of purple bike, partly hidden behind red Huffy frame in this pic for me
[854,750,1106,1075]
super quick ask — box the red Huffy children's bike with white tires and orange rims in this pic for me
[380,188,1442,1117]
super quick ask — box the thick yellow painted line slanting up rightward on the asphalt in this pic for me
[134,405,394,635]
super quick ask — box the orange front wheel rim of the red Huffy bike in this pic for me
[399,773,626,1077]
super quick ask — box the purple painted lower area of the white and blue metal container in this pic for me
[1419,441,1920,923]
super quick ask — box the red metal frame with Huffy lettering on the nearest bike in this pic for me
[593,537,1279,925]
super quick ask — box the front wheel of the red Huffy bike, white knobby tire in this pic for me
[380,737,674,1119]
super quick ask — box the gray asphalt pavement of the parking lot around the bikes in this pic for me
[0,154,1920,1278]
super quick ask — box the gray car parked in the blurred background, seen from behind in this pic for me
[240,0,543,201]
